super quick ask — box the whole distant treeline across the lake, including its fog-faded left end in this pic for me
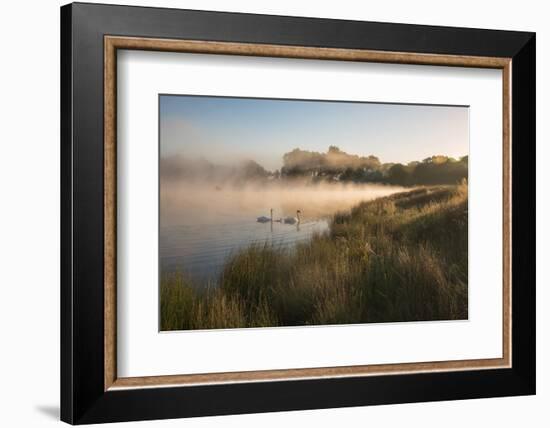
[160,146,468,186]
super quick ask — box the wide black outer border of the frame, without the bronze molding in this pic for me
[61,3,536,424]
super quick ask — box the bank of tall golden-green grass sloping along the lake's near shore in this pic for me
[161,184,468,330]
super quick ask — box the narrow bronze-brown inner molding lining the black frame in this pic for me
[104,36,512,391]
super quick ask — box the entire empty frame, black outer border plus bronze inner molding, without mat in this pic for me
[61,3,535,424]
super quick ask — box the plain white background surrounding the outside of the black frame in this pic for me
[0,0,550,428]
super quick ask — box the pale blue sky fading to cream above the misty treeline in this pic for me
[159,95,469,170]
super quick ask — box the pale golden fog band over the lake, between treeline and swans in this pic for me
[160,180,405,227]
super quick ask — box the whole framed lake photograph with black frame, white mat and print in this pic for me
[61,3,535,424]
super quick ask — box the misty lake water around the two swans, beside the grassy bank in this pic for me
[159,183,402,285]
